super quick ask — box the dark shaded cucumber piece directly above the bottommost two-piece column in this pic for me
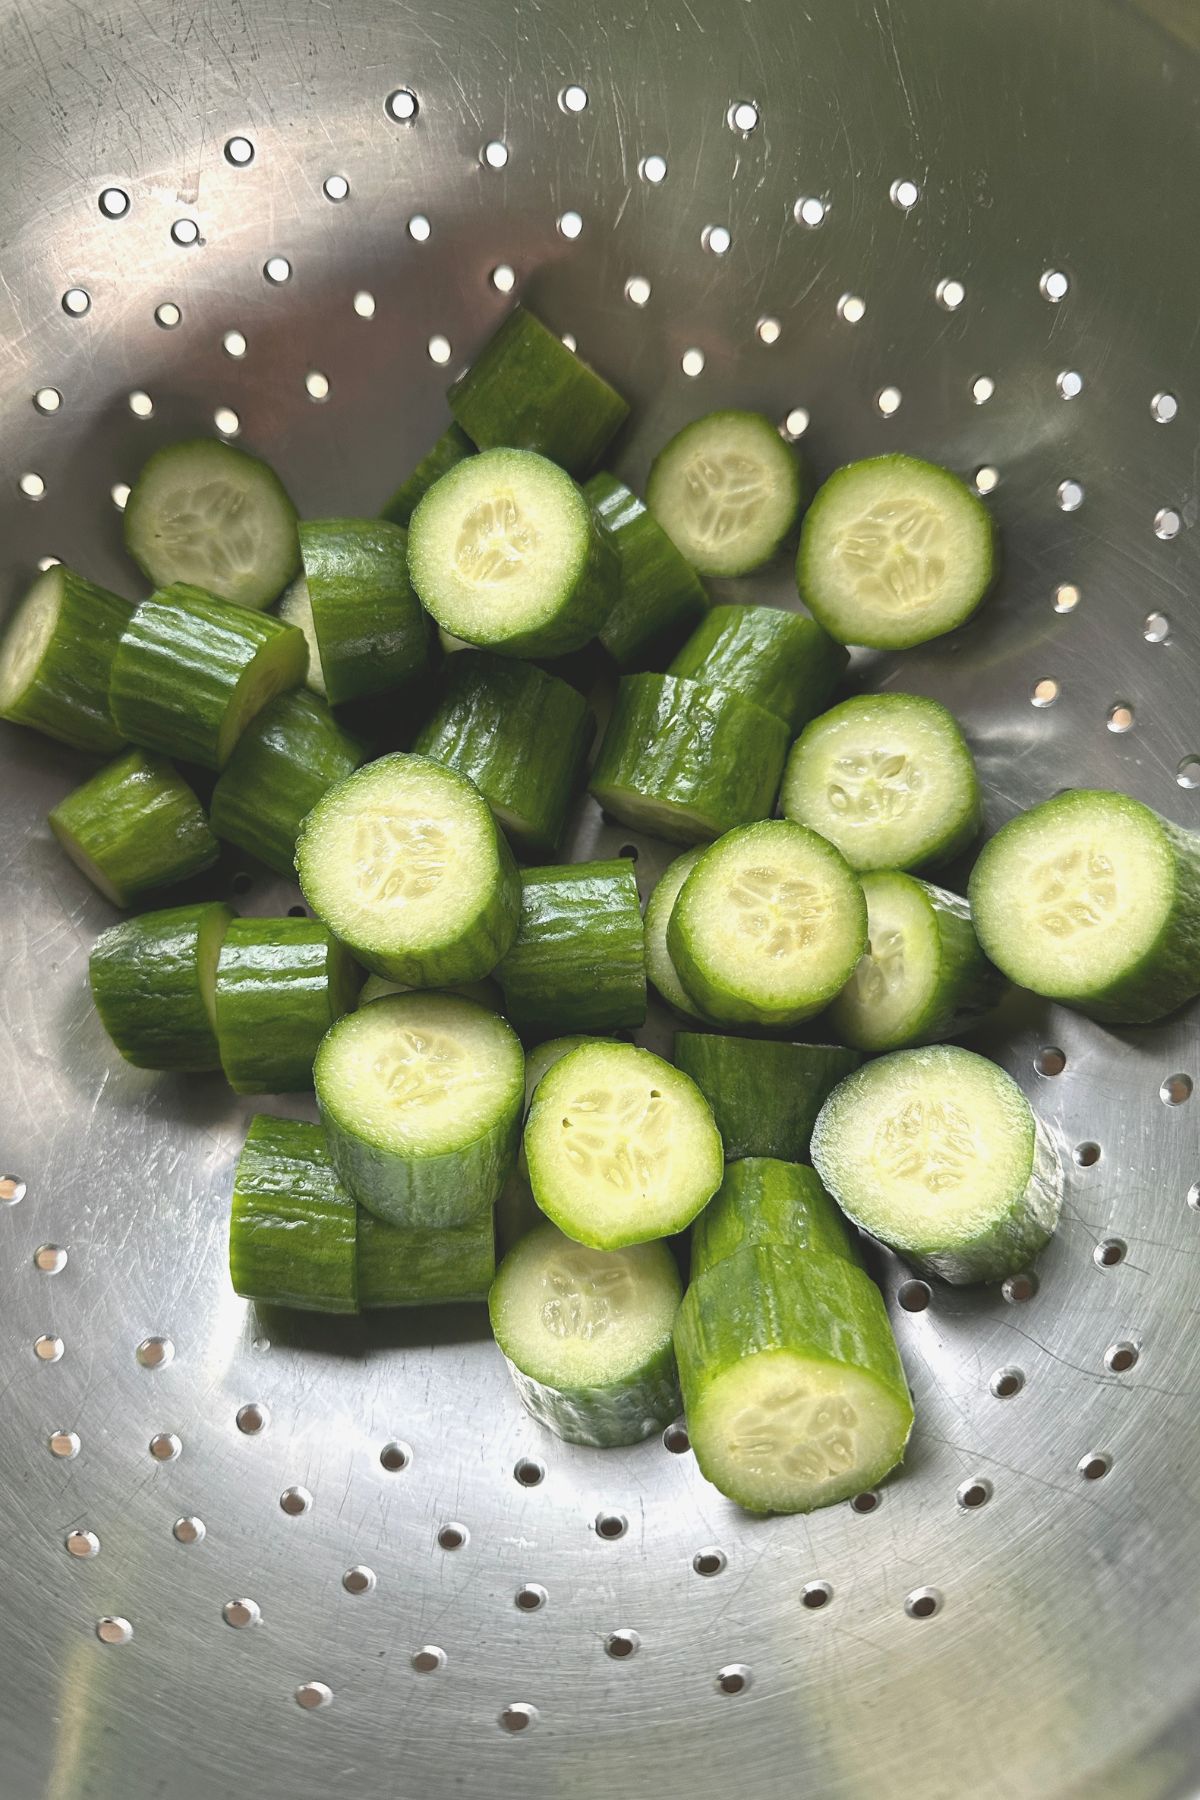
[675,1031,862,1163]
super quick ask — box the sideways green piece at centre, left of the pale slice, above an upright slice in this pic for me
[588,675,788,844]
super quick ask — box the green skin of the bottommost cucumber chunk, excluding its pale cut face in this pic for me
[675,1244,912,1512]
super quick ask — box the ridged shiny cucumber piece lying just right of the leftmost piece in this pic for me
[110,583,308,769]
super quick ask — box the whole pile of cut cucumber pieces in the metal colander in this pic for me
[0,308,1200,1512]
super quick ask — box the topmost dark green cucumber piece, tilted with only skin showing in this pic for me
[448,306,630,475]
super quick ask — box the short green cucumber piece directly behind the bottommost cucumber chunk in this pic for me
[691,1156,858,1282]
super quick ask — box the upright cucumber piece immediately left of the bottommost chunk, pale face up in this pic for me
[488,1224,680,1447]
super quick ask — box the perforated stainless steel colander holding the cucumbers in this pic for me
[0,0,1200,1800]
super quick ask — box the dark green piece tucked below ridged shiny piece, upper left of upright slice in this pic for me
[210,688,367,875]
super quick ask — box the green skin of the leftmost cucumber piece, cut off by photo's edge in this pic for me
[0,565,133,756]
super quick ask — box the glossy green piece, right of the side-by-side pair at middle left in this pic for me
[216,918,362,1094]
